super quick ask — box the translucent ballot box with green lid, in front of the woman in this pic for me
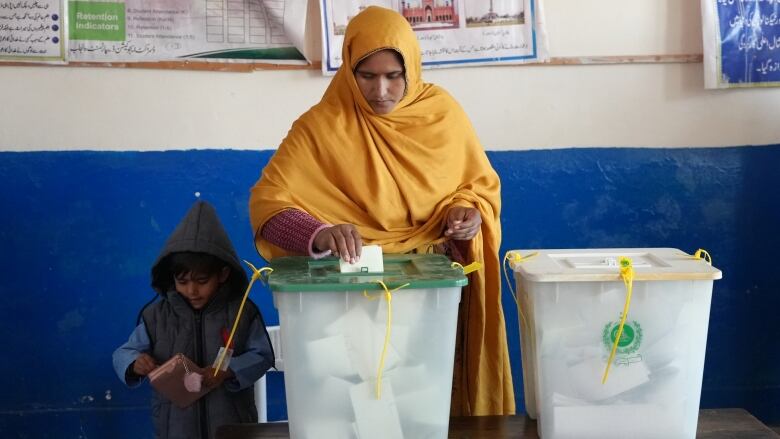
[269,254,467,439]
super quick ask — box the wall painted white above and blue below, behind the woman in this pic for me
[0,0,780,438]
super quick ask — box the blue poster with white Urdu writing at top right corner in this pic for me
[702,0,780,88]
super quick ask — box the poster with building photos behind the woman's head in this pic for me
[320,0,547,75]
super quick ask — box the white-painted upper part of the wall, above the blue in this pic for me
[0,0,780,151]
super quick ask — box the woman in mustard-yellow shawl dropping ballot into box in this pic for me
[249,7,515,415]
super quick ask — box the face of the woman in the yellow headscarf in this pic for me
[355,49,406,114]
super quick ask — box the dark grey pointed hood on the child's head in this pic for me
[152,200,249,295]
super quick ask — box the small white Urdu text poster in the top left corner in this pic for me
[0,0,67,63]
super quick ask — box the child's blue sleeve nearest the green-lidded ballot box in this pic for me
[225,318,274,392]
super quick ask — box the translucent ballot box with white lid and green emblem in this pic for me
[510,248,721,439]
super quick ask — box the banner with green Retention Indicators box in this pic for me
[67,0,306,64]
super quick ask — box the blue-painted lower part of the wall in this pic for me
[0,145,780,438]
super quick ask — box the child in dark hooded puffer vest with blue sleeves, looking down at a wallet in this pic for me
[113,201,274,439]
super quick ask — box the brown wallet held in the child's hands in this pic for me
[149,354,213,408]
